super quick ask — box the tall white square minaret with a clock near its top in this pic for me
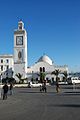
[14,21,27,80]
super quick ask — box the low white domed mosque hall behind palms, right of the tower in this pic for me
[27,55,68,81]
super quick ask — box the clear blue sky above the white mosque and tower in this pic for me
[0,0,80,72]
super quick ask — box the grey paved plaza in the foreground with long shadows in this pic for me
[0,85,80,120]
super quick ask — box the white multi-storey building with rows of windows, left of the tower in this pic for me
[0,54,14,78]
